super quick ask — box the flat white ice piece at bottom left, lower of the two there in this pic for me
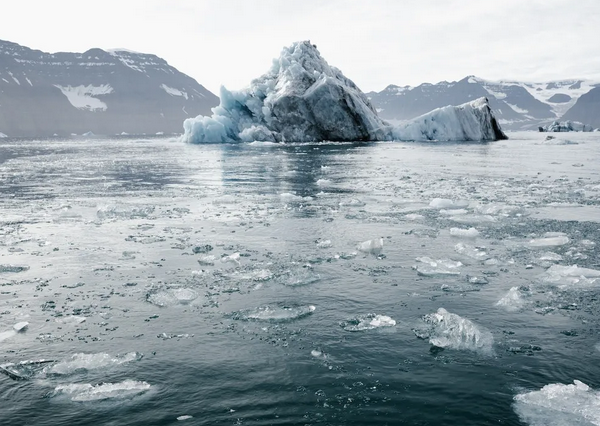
[52,380,152,402]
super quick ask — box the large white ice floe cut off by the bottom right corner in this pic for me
[513,380,600,426]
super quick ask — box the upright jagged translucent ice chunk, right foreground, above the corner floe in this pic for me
[423,308,494,355]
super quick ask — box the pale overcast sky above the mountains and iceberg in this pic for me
[0,0,600,94]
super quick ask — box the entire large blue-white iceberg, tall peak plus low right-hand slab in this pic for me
[182,41,506,143]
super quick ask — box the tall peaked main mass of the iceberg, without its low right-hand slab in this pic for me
[184,41,390,143]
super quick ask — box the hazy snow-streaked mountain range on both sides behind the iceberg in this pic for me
[0,40,600,137]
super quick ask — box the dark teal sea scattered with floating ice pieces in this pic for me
[0,133,600,426]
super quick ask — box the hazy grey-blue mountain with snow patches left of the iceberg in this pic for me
[0,40,219,137]
